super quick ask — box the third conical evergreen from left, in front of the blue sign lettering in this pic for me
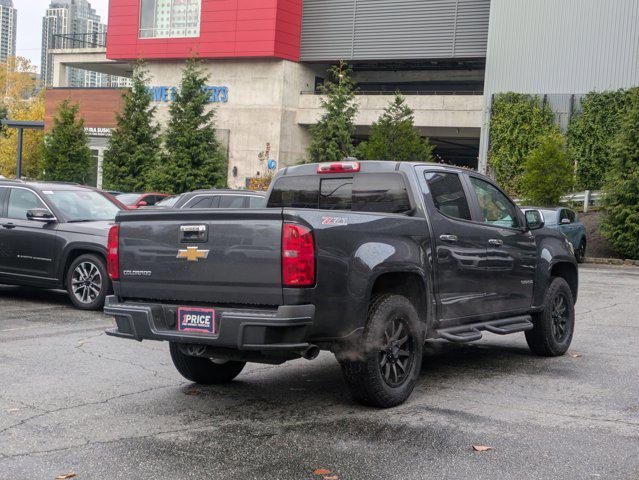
[149,58,228,194]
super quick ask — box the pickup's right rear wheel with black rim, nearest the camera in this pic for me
[340,295,424,408]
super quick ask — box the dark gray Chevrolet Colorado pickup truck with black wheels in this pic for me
[105,161,578,407]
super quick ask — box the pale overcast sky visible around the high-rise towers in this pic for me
[13,0,109,71]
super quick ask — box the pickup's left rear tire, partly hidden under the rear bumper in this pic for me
[169,342,246,385]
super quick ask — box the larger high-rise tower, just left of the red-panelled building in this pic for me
[41,0,125,87]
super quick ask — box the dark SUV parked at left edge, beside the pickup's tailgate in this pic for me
[0,180,122,310]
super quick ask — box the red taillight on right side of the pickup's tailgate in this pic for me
[282,223,315,287]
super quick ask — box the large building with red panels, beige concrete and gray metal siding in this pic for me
[45,0,639,186]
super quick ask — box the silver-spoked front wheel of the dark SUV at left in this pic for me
[66,254,111,310]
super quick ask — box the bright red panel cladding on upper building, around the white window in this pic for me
[107,0,302,61]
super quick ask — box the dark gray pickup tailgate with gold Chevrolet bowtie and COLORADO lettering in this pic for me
[116,209,282,305]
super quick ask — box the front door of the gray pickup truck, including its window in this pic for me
[466,175,537,314]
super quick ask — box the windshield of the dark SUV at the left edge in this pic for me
[44,190,121,222]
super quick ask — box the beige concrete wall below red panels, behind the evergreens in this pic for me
[147,59,315,187]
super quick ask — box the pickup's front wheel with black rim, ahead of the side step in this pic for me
[526,277,575,357]
